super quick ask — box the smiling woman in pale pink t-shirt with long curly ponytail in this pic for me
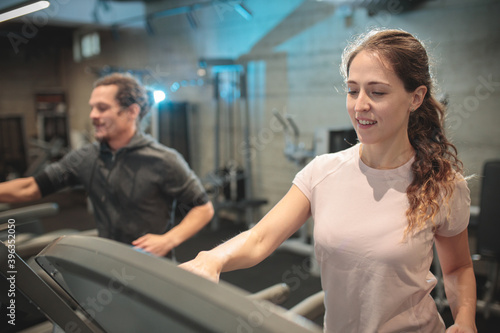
[181,30,476,333]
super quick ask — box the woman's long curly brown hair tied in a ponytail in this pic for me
[342,30,463,235]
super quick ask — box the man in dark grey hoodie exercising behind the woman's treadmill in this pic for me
[0,73,214,256]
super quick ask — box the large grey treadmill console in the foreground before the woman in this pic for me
[0,235,322,333]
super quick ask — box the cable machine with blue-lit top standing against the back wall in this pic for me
[200,59,267,229]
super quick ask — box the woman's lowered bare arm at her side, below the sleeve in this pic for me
[436,229,477,333]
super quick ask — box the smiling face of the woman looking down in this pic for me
[347,51,418,145]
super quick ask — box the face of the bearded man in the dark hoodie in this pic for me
[89,85,135,142]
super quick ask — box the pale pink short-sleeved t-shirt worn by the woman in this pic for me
[293,144,470,333]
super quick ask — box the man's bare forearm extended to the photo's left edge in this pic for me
[0,177,42,203]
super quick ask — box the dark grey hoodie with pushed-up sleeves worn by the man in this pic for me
[35,133,208,244]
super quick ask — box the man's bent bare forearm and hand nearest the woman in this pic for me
[132,201,214,256]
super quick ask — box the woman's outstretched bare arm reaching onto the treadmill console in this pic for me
[179,185,311,281]
